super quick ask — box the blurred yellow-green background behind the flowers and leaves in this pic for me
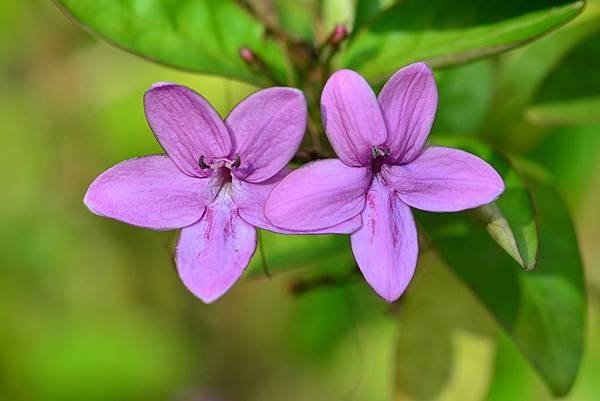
[0,0,600,401]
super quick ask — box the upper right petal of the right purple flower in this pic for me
[379,63,438,163]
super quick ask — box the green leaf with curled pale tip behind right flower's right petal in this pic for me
[435,136,538,270]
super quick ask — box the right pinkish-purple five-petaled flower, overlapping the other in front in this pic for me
[265,63,504,302]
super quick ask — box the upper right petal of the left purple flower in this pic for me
[226,88,307,182]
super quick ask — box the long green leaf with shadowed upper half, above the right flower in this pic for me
[341,0,584,82]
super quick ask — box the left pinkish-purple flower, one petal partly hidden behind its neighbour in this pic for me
[84,83,360,303]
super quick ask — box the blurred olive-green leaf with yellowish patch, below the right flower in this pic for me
[394,252,498,401]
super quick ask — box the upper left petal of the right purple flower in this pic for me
[321,70,387,167]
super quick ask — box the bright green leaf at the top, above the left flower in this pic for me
[55,0,285,85]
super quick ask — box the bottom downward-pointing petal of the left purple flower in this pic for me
[175,190,256,303]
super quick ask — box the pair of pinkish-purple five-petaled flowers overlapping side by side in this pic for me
[84,63,504,302]
